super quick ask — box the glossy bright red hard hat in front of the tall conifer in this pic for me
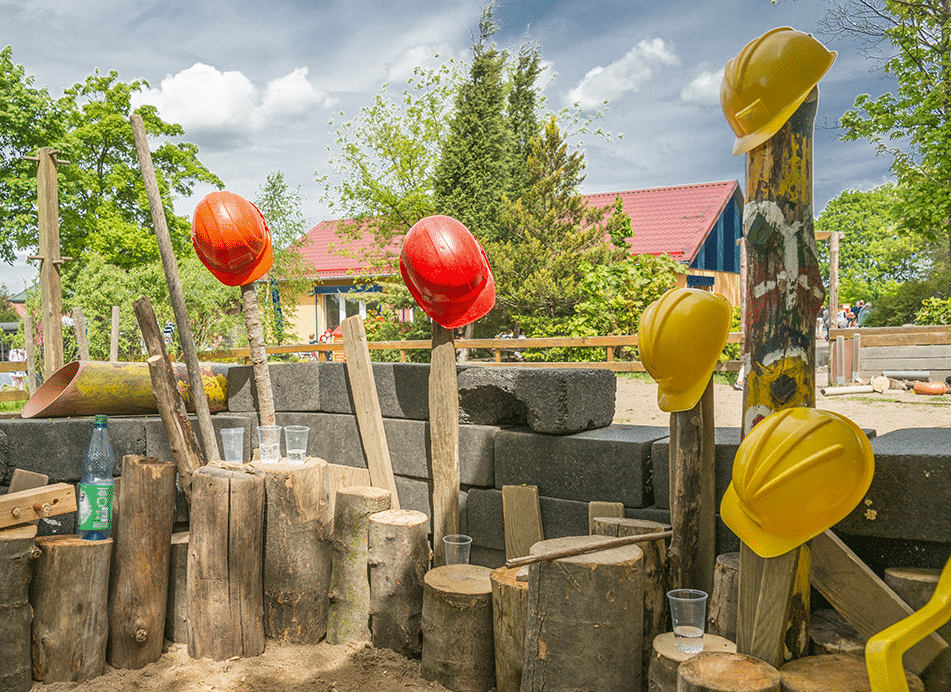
[400,216,495,329]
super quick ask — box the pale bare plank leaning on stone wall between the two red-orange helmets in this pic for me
[340,315,400,509]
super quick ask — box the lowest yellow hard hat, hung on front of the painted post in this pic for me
[720,408,875,557]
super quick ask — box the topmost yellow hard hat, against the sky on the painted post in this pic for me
[720,26,836,156]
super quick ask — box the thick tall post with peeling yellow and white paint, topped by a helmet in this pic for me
[737,89,825,667]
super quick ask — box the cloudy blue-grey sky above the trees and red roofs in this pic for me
[0,0,892,293]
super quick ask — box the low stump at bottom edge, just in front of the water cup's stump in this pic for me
[677,652,780,692]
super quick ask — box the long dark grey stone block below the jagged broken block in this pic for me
[495,425,667,507]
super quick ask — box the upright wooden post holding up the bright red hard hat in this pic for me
[429,322,459,565]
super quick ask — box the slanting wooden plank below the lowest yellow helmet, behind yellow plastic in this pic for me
[808,531,948,675]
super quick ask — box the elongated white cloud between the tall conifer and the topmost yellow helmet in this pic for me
[565,38,680,108]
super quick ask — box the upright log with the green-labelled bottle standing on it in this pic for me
[30,536,113,685]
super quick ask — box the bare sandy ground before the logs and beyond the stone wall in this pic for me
[26,373,951,692]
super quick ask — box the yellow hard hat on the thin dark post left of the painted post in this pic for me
[637,288,733,413]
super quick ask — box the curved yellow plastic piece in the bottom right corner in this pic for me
[865,560,951,692]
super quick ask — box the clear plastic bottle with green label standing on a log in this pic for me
[76,415,116,541]
